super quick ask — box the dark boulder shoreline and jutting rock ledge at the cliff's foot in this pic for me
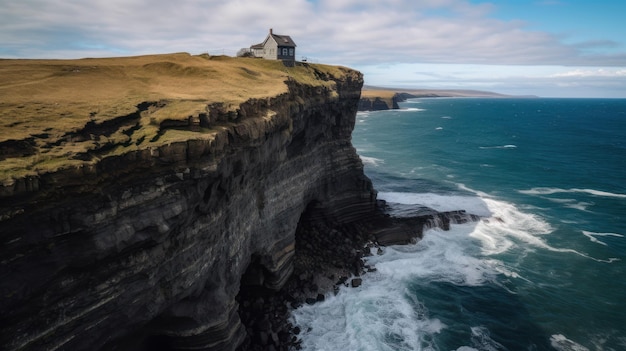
[237,201,481,351]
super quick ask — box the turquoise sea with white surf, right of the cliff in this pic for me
[292,98,626,351]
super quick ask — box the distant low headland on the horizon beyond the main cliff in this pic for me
[359,85,537,111]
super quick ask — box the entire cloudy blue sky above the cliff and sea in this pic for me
[0,0,626,98]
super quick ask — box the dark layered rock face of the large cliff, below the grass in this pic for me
[0,65,375,350]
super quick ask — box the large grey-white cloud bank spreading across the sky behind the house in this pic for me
[0,0,626,66]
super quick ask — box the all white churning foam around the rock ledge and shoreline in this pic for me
[292,190,622,351]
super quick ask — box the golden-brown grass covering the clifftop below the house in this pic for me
[0,53,344,184]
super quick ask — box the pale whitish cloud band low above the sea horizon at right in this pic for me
[357,64,626,98]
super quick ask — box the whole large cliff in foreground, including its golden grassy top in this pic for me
[0,54,376,350]
